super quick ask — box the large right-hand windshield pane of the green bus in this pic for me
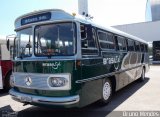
[34,22,75,56]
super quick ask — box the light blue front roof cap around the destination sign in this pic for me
[15,9,74,28]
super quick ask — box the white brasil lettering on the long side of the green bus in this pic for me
[103,56,120,65]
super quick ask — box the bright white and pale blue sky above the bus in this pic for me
[0,0,146,36]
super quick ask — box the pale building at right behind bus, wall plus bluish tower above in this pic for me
[113,0,160,42]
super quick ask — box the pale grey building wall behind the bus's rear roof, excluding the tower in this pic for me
[113,21,160,42]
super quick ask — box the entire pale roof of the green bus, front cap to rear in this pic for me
[15,9,147,44]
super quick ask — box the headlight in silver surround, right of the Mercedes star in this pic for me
[48,74,71,90]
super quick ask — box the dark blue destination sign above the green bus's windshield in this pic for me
[21,12,51,25]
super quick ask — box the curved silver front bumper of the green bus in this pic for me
[9,89,80,106]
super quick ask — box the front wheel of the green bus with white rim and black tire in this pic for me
[100,79,112,106]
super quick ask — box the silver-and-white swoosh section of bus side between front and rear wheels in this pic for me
[117,52,142,90]
